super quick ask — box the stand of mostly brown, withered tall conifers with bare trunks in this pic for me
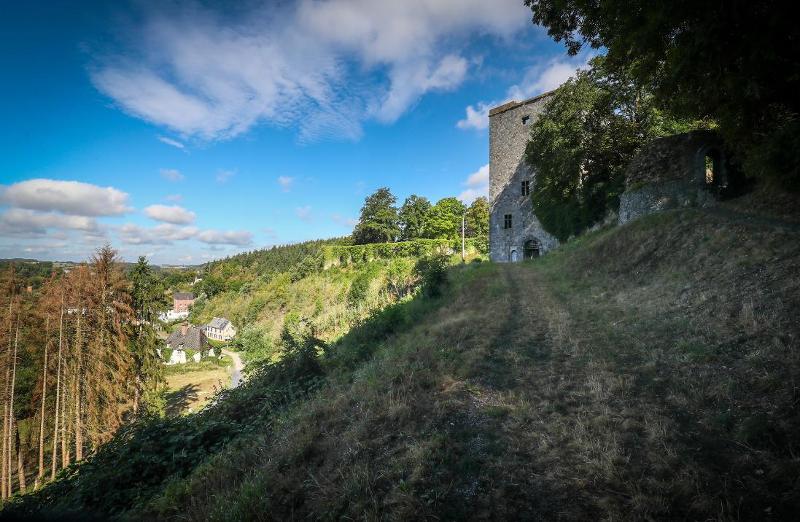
[0,247,164,498]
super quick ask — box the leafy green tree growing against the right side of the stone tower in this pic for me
[525,57,700,241]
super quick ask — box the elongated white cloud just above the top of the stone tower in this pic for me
[456,54,592,130]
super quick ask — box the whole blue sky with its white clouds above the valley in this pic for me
[0,0,586,264]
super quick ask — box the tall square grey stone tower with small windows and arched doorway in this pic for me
[489,93,558,263]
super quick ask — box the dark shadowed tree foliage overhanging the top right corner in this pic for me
[525,0,800,189]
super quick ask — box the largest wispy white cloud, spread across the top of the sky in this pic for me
[92,0,529,143]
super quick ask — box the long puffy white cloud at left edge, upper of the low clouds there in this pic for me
[0,179,131,216]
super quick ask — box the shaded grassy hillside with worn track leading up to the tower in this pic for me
[5,190,800,520]
